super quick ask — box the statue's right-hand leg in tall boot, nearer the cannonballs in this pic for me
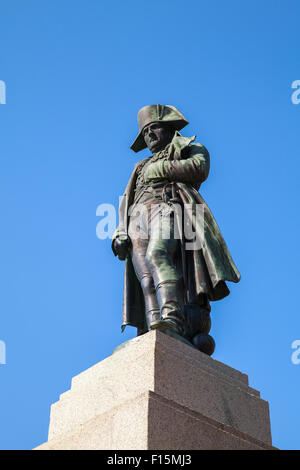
[146,204,185,335]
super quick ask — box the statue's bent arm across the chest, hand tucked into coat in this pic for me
[145,143,210,183]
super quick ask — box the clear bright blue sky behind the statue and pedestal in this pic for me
[0,0,300,449]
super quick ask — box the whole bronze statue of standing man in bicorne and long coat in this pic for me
[112,105,240,355]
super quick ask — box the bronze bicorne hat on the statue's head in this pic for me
[130,104,188,152]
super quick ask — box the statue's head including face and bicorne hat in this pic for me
[131,104,188,153]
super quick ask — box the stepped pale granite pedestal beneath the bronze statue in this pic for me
[37,331,272,450]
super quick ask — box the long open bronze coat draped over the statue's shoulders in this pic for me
[112,132,240,329]
